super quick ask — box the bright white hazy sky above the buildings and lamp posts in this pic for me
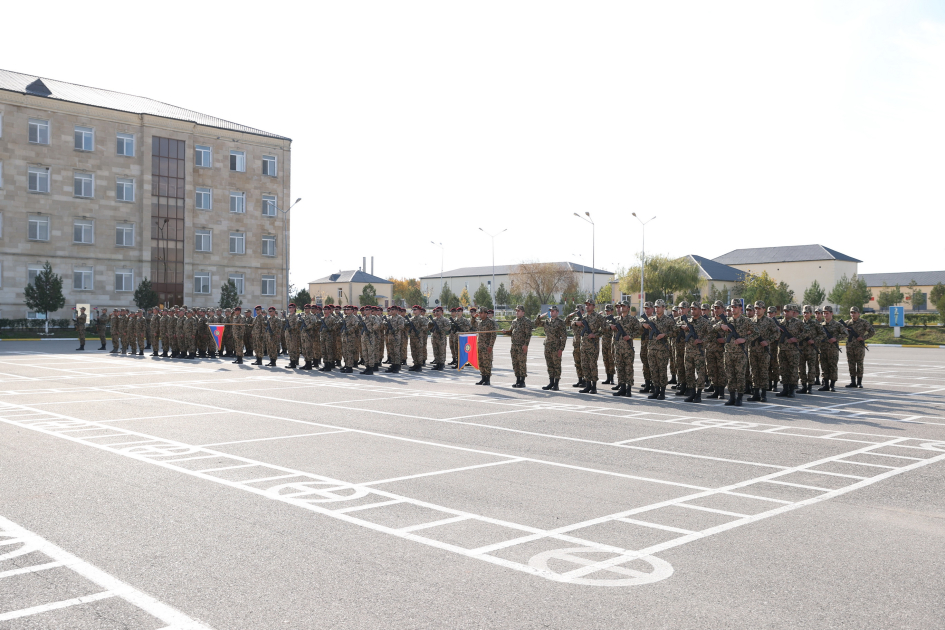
[0,0,945,284]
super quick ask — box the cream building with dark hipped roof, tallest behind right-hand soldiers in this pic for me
[713,245,863,301]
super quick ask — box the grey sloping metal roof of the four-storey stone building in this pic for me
[0,70,291,140]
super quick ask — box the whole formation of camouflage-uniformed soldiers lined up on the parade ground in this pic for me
[85,299,875,407]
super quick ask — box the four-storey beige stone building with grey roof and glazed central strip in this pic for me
[0,70,291,317]
